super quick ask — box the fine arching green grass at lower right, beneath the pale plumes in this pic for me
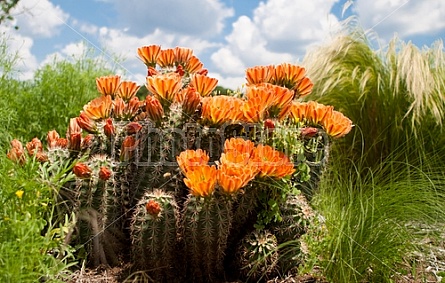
[309,163,445,282]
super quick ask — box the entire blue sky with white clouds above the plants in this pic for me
[0,0,445,88]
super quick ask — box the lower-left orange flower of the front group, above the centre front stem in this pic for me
[184,165,217,197]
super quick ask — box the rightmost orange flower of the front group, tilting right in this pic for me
[253,145,295,178]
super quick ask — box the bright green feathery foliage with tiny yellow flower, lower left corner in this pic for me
[0,156,72,282]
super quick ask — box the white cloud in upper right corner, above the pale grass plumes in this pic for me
[354,0,445,41]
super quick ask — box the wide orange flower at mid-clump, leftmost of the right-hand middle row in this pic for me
[201,95,244,125]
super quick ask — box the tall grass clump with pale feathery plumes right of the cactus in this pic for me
[304,30,445,171]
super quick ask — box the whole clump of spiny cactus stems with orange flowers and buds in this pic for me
[8,45,352,282]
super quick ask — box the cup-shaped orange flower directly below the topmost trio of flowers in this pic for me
[146,73,182,103]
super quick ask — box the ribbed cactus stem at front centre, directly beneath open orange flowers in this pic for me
[182,195,232,282]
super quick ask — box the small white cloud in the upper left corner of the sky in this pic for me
[11,0,69,38]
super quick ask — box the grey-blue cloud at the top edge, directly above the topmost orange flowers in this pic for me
[110,0,234,37]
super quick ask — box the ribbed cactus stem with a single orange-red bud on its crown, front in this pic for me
[130,190,181,282]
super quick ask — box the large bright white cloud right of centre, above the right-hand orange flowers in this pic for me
[211,0,340,88]
